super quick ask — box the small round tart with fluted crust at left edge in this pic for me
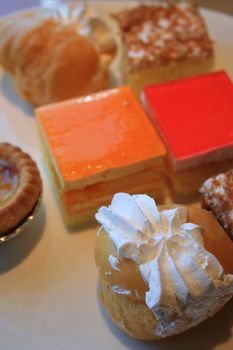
[0,143,42,236]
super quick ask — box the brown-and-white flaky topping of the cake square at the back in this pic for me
[113,1,213,71]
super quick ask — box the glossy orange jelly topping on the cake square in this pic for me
[36,87,165,186]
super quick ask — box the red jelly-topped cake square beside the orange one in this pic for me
[143,71,233,195]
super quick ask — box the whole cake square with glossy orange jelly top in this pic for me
[36,87,165,226]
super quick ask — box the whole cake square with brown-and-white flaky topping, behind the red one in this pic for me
[113,1,214,96]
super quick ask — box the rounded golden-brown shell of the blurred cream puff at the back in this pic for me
[15,20,99,106]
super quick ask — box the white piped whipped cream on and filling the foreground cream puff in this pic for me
[96,193,233,336]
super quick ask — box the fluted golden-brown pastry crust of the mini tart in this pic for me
[0,143,42,235]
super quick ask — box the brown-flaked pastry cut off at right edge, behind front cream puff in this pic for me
[200,169,233,239]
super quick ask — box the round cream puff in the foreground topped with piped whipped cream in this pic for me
[95,193,233,340]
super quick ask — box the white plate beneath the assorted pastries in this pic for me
[0,2,233,350]
